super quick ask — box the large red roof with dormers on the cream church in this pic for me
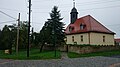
[65,15,115,34]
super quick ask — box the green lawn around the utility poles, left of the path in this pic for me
[0,49,61,60]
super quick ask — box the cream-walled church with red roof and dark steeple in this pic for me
[65,2,115,45]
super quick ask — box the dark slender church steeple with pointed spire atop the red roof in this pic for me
[70,0,78,24]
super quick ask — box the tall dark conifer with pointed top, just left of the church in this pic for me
[48,6,65,45]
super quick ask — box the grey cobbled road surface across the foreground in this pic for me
[0,56,120,67]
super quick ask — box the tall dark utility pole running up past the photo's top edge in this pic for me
[27,0,31,57]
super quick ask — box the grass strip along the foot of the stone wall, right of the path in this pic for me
[68,50,120,58]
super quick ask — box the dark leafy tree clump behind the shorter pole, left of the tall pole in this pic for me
[0,21,28,54]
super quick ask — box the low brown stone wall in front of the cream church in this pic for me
[59,45,120,54]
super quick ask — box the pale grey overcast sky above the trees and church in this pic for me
[0,0,120,38]
